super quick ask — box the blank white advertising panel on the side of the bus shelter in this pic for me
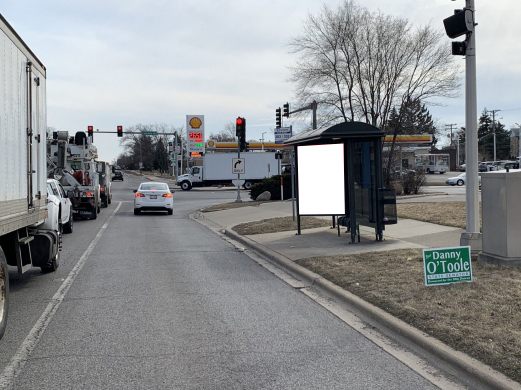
[297,144,345,215]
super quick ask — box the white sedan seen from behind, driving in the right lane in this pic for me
[134,182,174,215]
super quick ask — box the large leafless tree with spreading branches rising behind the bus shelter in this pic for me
[289,0,461,184]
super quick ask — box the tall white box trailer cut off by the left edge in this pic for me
[0,14,61,338]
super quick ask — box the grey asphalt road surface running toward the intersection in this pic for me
[0,175,435,390]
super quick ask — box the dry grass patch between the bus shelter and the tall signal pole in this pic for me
[396,202,481,229]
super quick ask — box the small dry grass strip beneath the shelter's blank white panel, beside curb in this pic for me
[233,217,331,236]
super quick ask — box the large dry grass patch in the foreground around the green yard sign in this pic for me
[297,249,521,381]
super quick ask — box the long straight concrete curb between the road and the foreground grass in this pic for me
[221,225,521,390]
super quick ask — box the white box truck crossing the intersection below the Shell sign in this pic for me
[176,152,278,191]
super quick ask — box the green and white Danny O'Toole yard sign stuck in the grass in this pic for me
[423,246,472,286]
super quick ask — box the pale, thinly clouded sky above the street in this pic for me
[0,0,521,161]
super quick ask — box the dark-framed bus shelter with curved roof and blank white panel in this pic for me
[285,122,397,243]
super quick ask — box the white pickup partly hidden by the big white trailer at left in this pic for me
[46,179,74,233]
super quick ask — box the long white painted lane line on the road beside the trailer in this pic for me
[0,202,122,389]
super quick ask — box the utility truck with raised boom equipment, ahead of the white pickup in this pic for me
[49,131,101,219]
